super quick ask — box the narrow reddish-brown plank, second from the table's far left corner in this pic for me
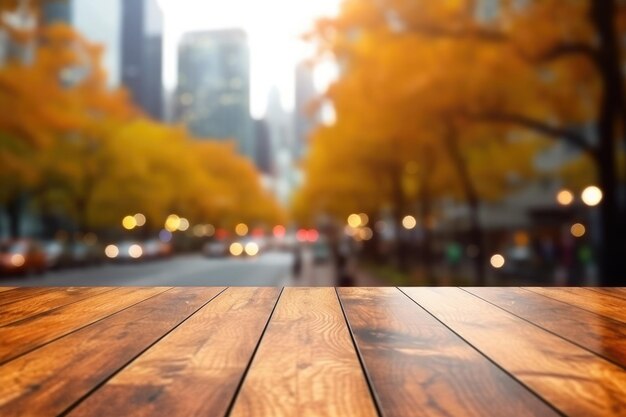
[0,287,113,326]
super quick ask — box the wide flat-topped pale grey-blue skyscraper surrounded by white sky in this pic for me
[176,29,256,160]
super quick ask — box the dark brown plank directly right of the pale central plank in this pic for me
[338,288,557,417]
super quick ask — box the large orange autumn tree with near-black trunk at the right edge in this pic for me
[304,0,625,283]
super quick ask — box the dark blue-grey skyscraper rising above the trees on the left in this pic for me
[121,0,163,119]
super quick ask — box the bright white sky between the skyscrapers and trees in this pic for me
[159,0,341,117]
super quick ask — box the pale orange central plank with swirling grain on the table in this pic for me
[230,288,377,417]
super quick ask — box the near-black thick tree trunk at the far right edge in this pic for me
[590,0,626,286]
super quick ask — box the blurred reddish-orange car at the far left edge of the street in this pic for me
[0,239,47,275]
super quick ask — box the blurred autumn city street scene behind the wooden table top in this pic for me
[0,0,626,286]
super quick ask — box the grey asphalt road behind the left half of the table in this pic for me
[0,252,293,287]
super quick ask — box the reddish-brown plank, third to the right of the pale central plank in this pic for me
[465,288,626,367]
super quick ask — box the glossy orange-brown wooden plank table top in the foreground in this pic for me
[0,287,626,417]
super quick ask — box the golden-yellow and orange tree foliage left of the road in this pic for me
[0,16,283,236]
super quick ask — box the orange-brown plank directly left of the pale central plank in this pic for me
[69,288,280,417]
